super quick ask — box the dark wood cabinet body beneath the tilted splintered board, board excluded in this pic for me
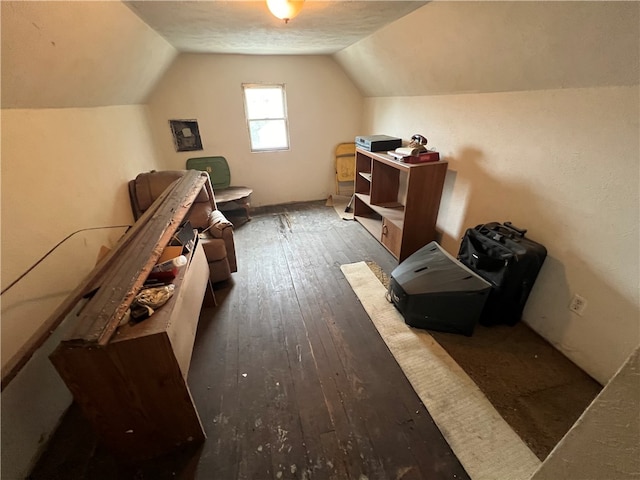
[51,240,209,460]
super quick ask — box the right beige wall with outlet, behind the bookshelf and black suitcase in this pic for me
[365,87,640,384]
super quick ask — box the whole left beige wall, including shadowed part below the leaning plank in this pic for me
[1,106,157,478]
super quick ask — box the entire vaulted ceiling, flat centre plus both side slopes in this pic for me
[0,0,640,109]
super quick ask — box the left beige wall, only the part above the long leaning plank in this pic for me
[1,106,156,369]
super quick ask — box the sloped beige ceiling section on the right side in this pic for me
[335,1,640,97]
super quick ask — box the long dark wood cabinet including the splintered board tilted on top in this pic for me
[50,170,215,460]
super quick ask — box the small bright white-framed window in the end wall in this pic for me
[242,84,289,152]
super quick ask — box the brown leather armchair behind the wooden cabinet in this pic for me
[129,170,238,283]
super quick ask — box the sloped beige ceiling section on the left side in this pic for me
[0,1,178,108]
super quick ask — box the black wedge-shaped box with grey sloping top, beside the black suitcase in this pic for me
[389,242,491,335]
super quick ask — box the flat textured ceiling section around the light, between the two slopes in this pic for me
[124,0,427,55]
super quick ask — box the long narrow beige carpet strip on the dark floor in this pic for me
[340,262,540,480]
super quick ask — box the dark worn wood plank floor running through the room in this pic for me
[31,202,469,480]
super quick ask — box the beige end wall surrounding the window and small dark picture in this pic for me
[149,54,362,206]
